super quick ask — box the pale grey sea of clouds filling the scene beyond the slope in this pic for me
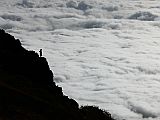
[0,0,160,120]
